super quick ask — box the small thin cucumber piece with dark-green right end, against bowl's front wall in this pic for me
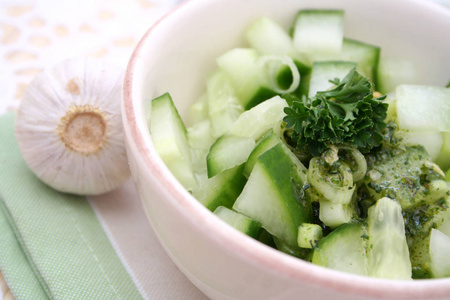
[214,206,261,238]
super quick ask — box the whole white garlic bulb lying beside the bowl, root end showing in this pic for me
[15,58,130,195]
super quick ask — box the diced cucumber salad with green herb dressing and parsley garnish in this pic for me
[146,9,450,279]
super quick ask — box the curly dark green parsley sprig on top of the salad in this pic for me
[284,68,388,156]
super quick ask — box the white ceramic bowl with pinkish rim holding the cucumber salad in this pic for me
[123,0,450,300]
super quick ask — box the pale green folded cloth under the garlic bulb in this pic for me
[0,114,142,300]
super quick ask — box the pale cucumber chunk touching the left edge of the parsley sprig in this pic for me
[229,96,287,141]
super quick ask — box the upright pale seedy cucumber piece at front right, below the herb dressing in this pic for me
[367,197,412,279]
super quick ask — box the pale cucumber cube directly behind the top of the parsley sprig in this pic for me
[308,61,356,97]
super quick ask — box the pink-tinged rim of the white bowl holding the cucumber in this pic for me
[122,0,450,299]
